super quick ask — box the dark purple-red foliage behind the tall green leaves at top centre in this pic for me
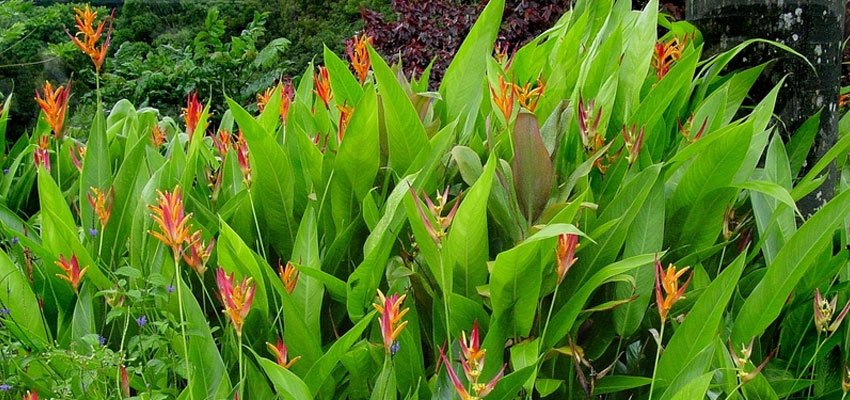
[361,0,572,82]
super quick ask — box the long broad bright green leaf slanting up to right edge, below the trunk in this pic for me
[732,189,850,343]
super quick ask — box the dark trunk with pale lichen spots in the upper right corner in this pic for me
[685,0,844,216]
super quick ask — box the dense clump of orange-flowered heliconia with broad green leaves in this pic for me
[0,0,850,400]
